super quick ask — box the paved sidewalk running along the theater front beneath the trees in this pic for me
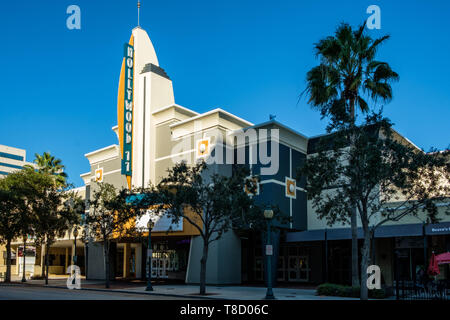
[0,278,359,300]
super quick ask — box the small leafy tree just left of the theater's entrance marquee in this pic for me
[86,183,138,288]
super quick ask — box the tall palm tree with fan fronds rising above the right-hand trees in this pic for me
[304,23,399,287]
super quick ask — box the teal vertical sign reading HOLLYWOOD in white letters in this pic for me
[122,43,134,176]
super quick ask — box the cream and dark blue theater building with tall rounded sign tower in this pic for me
[75,23,450,284]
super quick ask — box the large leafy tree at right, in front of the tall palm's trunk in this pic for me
[300,114,450,299]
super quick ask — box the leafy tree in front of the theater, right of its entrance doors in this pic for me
[140,161,262,295]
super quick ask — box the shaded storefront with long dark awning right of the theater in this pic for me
[286,222,450,286]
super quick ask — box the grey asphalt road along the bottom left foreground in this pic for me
[0,286,199,300]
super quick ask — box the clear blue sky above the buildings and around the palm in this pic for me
[0,0,450,186]
